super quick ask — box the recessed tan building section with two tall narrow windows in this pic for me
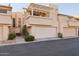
[12,12,24,34]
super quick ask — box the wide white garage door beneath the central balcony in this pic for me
[32,26,57,38]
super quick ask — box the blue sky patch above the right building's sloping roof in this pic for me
[57,3,79,16]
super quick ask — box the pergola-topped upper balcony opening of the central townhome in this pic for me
[26,3,52,17]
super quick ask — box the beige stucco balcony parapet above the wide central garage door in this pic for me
[27,16,54,26]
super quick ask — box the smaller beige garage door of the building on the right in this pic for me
[63,27,76,37]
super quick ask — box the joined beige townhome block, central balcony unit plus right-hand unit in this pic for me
[24,3,79,38]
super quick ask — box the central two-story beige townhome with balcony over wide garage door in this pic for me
[24,3,58,38]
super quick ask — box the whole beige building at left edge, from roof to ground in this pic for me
[0,5,12,41]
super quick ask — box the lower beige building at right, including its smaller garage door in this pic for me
[58,14,79,37]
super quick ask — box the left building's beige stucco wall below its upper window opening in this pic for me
[0,13,12,41]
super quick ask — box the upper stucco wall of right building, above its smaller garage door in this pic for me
[58,14,79,27]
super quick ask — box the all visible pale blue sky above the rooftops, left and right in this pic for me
[2,3,79,16]
